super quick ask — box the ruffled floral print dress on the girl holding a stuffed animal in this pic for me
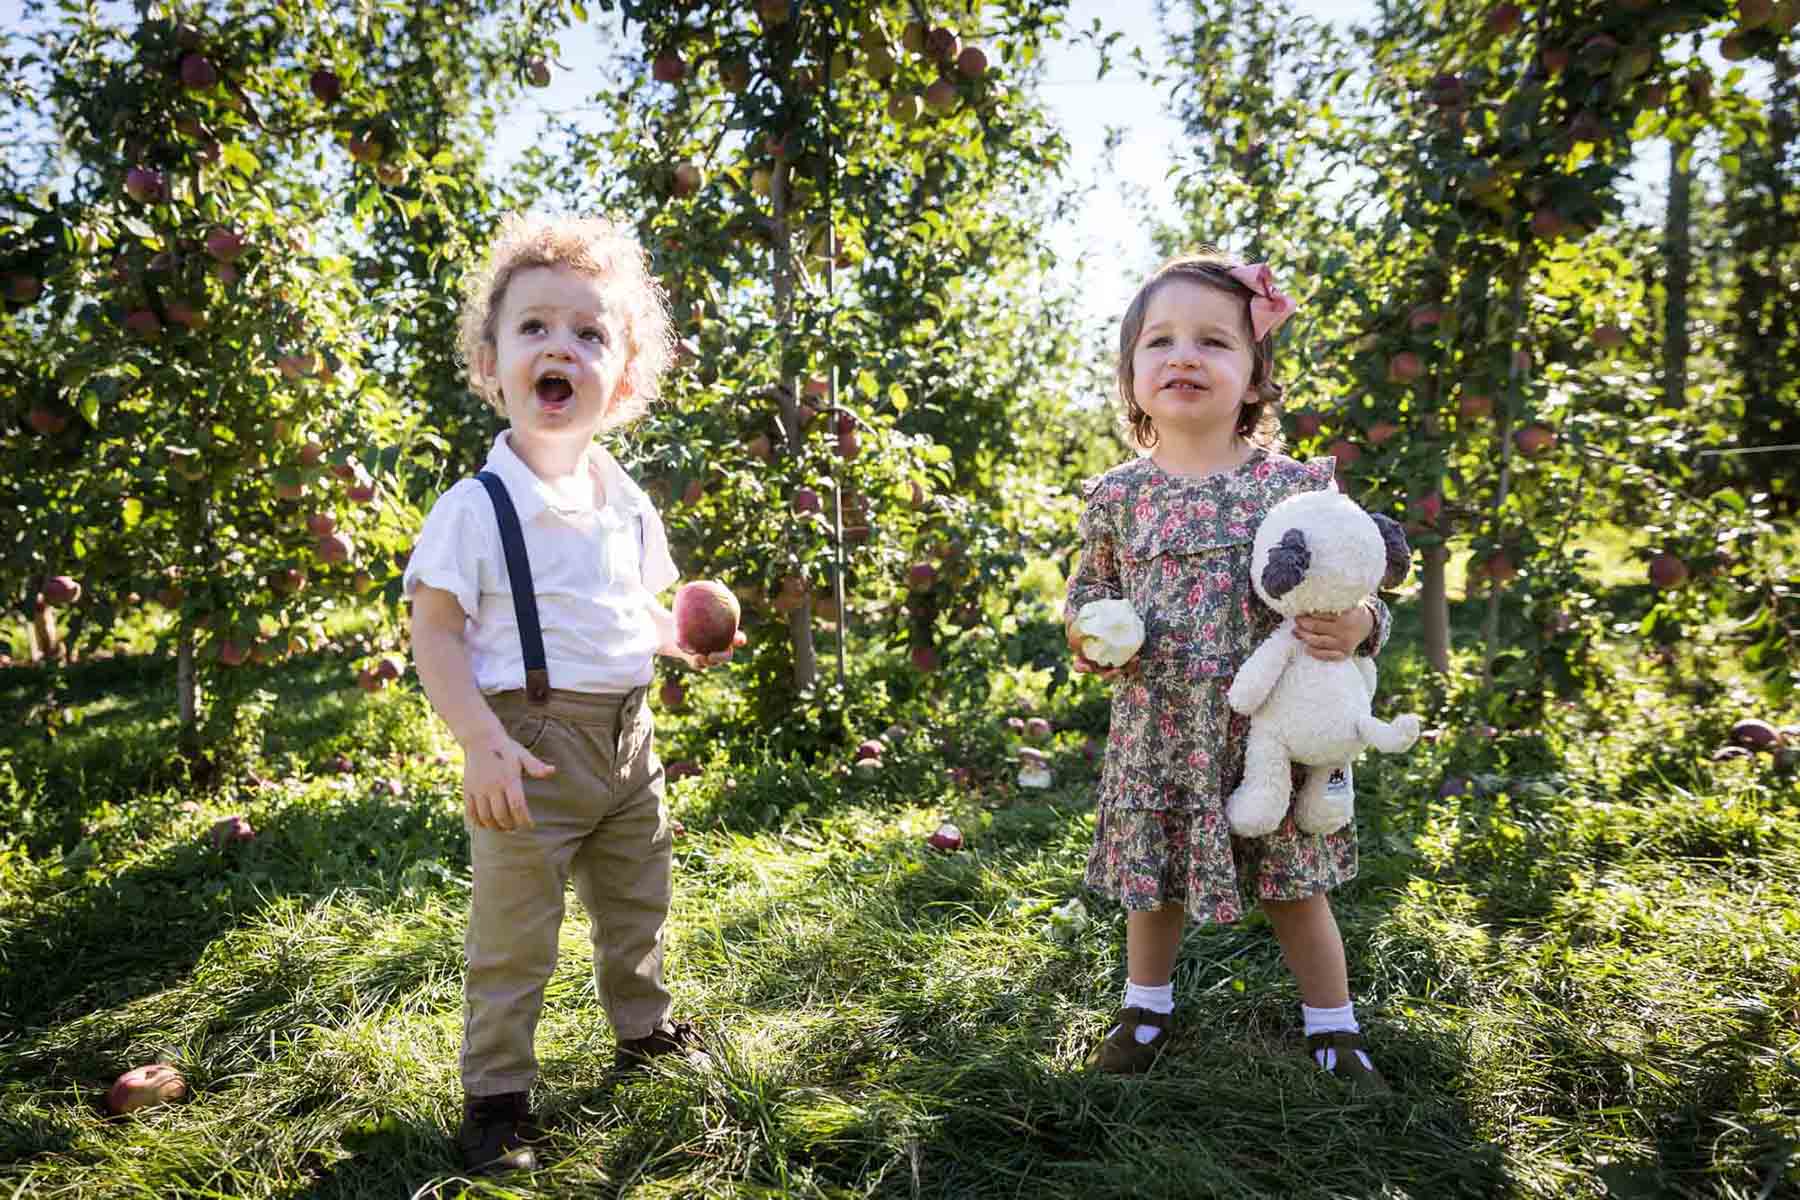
[1066,448,1390,921]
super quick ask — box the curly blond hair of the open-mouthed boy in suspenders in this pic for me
[457,212,675,428]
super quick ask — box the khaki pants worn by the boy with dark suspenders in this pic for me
[463,687,670,1096]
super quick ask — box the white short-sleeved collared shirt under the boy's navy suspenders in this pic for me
[403,432,679,694]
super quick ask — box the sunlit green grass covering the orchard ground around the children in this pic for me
[0,606,1800,1200]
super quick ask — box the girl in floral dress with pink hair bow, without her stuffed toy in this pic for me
[1066,254,1388,1090]
